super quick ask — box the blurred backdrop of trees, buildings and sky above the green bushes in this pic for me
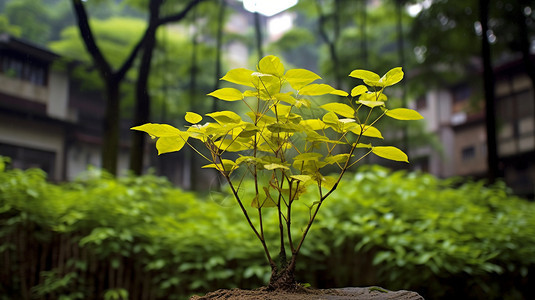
[0,0,535,197]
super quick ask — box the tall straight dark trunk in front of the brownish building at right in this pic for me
[479,0,499,183]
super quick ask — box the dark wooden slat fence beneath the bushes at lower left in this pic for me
[0,222,161,300]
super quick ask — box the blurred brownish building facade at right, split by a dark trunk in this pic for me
[415,60,535,198]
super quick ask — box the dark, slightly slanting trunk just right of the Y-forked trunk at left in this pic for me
[130,0,163,175]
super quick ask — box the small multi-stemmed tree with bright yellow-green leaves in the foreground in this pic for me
[132,56,422,289]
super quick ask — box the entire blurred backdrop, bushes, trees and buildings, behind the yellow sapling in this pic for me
[0,0,535,300]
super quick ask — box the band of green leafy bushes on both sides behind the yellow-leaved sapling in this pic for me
[0,162,535,299]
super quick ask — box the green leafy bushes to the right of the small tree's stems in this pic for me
[298,167,535,299]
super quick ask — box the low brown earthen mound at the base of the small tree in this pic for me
[190,287,424,300]
